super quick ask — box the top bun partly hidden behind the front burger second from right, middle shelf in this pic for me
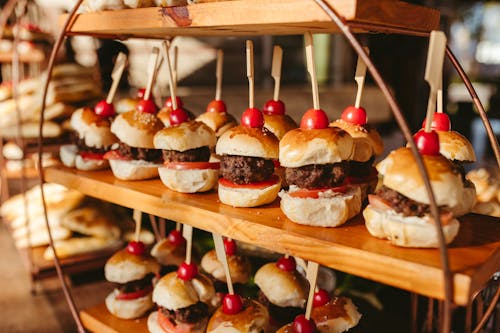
[330,119,384,162]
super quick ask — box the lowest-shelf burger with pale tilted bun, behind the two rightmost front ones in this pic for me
[254,257,309,327]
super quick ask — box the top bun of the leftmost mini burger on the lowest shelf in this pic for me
[104,248,160,283]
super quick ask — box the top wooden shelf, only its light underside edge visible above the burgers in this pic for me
[61,0,439,39]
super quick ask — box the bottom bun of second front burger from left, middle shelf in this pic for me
[109,160,158,180]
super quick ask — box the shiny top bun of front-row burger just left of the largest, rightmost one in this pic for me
[279,127,354,168]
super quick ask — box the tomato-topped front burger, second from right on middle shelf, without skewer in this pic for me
[279,109,361,227]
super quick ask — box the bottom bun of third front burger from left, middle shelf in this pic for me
[158,167,219,193]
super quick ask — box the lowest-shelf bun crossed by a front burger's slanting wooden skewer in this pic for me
[201,250,251,283]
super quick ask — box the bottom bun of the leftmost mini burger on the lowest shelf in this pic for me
[105,290,154,319]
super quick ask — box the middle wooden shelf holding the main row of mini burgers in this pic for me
[45,167,500,305]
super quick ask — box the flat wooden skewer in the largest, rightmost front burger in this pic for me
[425,31,446,132]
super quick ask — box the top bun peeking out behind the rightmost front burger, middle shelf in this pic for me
[436,131,476,162]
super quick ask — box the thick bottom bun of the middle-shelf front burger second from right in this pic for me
[280,186,361,227]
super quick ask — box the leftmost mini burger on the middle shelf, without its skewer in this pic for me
[59,107,118,170]
